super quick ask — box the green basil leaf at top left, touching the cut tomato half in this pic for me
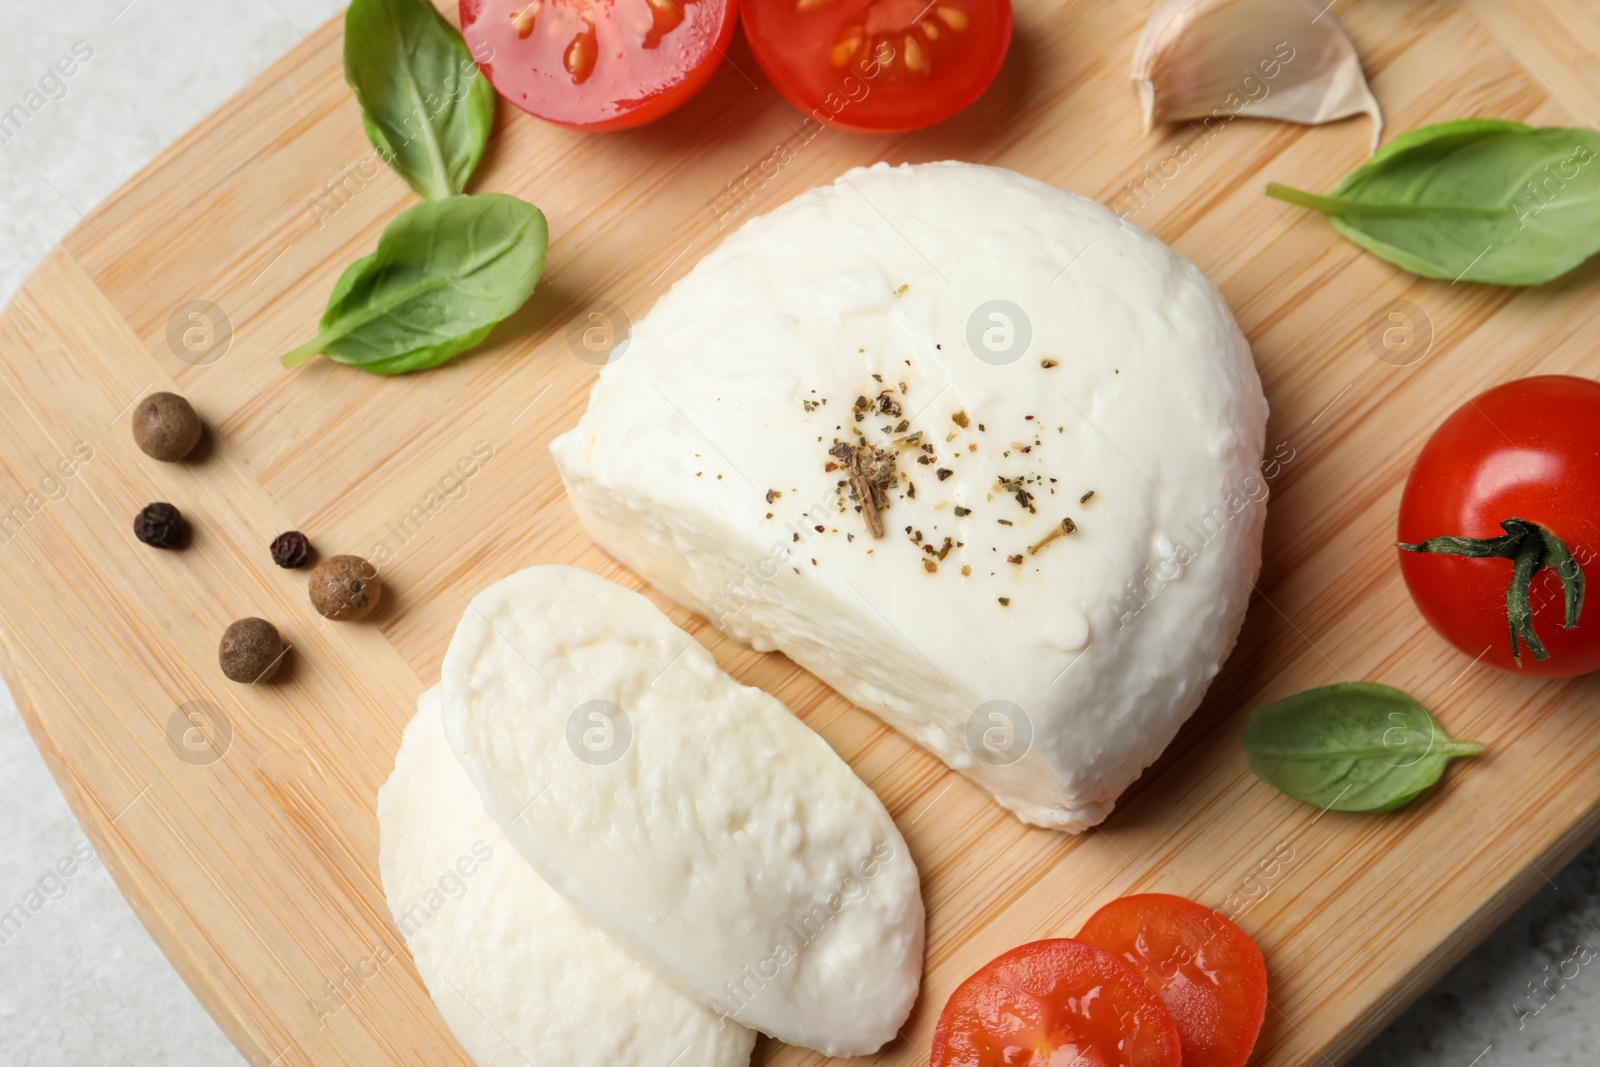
[344,0,494,200]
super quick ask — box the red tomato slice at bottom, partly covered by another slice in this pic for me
[1078,893,1267,1067]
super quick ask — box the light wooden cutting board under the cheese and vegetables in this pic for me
[0,0,1600,1067]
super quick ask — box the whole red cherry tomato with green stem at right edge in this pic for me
[1400,374,1600,678]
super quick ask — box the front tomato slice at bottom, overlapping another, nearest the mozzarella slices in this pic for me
[931,937,1184,1067]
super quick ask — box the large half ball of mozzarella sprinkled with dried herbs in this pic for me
[550,163,1267,830]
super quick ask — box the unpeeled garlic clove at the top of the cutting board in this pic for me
[1133,0,1384,149]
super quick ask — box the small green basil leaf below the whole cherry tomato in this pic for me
[1245,681,1483,811]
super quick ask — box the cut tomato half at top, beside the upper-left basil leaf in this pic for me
[461,0,739,130]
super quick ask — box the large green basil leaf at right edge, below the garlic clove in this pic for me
[1267,118,1600,285]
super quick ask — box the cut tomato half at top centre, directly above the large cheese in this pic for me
[744,0,1011,131]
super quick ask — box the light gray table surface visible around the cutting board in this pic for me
[0,0,1600,1067]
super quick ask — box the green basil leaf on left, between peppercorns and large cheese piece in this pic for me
[283,192,549,374]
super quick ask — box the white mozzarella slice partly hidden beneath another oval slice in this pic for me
[378,689,755,1067]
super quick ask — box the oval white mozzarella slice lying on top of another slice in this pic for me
[442,566,923,1056]
